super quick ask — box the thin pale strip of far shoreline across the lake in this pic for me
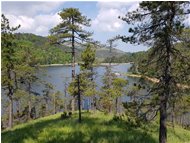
[38,62,132,67]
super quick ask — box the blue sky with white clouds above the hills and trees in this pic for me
[1,1,190,52]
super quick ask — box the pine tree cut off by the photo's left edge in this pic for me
[1,15,20,128]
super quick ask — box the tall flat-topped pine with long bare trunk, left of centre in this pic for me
[49,8,92,111]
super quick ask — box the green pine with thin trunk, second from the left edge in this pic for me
[15,40,38,120]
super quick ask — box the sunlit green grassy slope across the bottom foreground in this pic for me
[2,112,190,143]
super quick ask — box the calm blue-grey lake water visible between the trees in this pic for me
[32,63,148,105]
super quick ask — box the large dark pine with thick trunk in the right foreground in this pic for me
[121,1,190,143]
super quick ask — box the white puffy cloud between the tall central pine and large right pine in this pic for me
[92,2,139,32]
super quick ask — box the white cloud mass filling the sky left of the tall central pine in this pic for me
[2,1,63,36]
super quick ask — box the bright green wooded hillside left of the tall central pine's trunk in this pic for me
[15,33,71,65]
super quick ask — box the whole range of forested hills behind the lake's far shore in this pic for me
[16,33,126,65]
